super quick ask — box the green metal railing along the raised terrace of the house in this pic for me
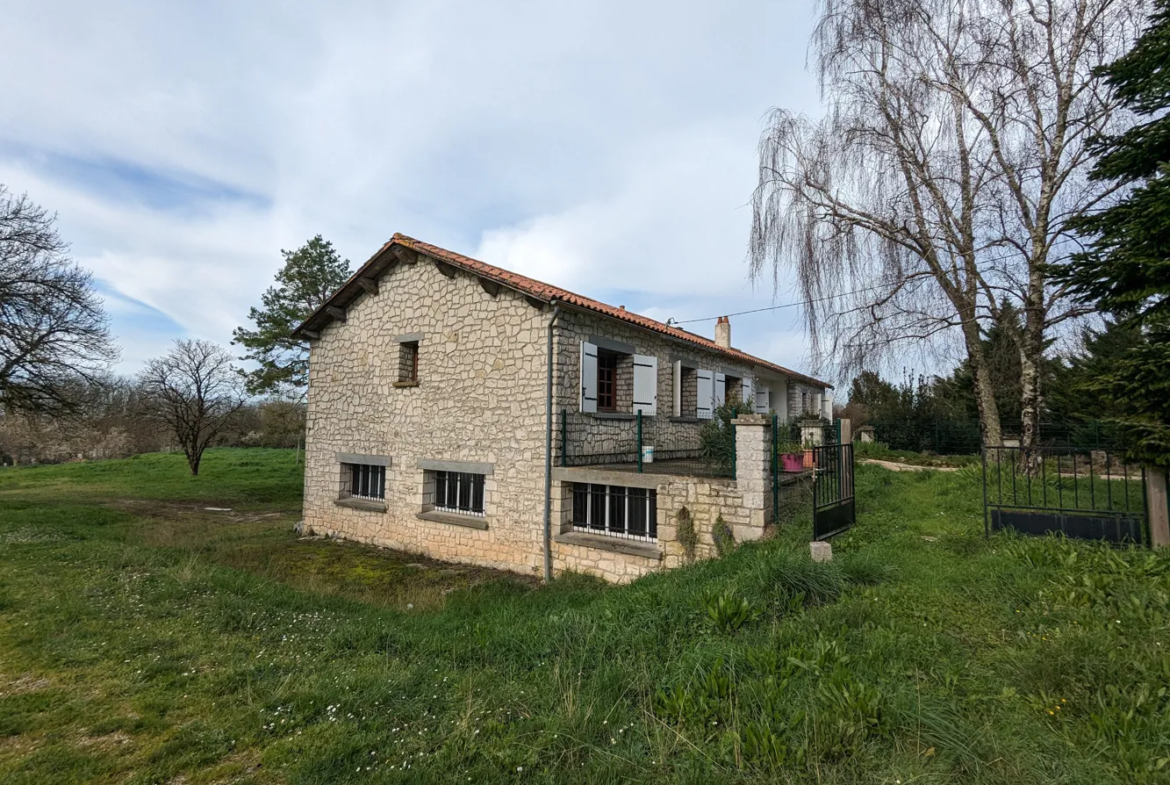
[555,409,735,477]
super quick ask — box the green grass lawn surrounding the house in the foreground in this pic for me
[0,450,1170,785]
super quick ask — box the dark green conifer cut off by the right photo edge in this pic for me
[1058,0,1170,464]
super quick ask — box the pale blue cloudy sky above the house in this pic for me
[0,0,819,381]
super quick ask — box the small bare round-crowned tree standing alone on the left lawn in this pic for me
[139,340,245,475]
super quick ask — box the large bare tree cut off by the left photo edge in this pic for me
[0,185,117,414]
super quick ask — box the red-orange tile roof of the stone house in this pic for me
[294,233,832,387]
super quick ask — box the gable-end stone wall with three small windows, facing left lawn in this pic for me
[304,260,550,574]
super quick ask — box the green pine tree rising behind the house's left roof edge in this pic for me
[232,234,350,398]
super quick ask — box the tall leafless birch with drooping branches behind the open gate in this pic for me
[749,0,1142,447]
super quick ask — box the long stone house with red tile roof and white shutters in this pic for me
[295,234,832,581]
